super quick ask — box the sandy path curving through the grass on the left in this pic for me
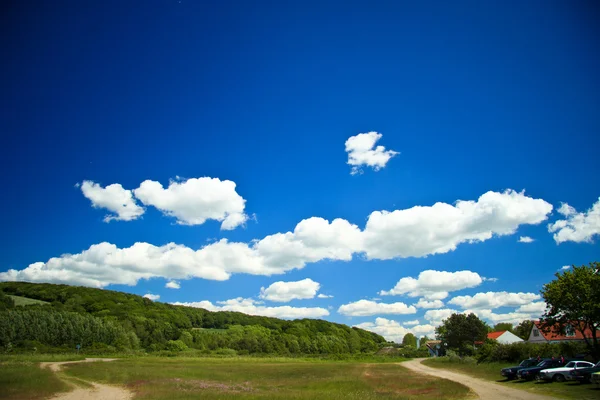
[40,358,133,400]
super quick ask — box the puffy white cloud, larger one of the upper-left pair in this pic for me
[133,177,248,230]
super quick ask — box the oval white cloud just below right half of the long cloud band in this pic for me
[379,270,483,300]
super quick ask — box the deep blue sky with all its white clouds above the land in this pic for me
[0,0,600,339]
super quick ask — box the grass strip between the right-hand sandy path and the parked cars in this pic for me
[423,358,600,400]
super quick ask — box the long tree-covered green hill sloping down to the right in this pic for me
[0,282,385,355]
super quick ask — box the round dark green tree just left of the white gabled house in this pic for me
[435,313,488,356]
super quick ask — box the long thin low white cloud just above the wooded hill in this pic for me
[171,297,329,319]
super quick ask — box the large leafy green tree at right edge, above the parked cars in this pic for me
[541,262,600,360]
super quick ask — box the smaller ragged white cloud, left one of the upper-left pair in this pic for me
[77,181,145,222]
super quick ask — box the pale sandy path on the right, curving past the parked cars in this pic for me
[400,358,555,400]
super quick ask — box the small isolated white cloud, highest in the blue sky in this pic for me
[346,132,399,175]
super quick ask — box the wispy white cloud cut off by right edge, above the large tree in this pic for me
[548,198,600,244]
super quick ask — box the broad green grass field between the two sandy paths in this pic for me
[59,357,471,400]
